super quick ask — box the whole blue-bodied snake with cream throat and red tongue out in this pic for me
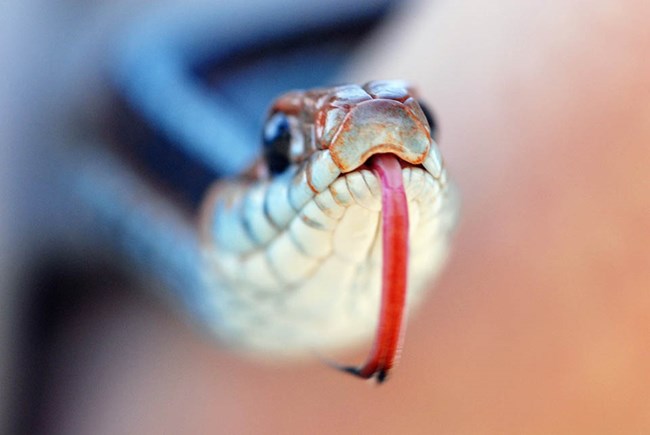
[68,0,458,382]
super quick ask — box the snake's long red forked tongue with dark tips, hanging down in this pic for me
[345,154,409,383]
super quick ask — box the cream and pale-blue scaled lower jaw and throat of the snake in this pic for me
[201,162,455,356]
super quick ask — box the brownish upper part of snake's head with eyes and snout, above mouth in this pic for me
[264,80,435,179]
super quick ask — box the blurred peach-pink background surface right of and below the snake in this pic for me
[5,0,650,434]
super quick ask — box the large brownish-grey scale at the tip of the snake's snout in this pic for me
[329,99,431,173]
